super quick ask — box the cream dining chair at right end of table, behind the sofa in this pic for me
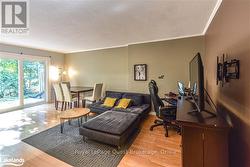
[82,83,103,107]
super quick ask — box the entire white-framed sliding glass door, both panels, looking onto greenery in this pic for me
[0,52,49,112]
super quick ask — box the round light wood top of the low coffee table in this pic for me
[59,108,90,119]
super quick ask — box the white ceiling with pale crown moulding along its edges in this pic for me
[0,0,218,53]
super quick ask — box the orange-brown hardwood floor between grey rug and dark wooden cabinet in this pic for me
[119,115,181,167]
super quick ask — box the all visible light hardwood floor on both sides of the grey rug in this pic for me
[0,104,181,167]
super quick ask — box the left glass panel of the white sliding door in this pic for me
[0,58,20,110]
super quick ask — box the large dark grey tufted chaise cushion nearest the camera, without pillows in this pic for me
[82,111,138,135]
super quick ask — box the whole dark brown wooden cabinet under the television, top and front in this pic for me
[176,97,230,167]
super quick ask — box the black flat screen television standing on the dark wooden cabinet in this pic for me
[189,53,205,112]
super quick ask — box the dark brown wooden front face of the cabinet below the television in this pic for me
[182,126,229,167]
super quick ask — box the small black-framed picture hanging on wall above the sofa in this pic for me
[134,64,147,81]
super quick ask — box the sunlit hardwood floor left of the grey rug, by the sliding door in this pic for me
[0,104,70,167]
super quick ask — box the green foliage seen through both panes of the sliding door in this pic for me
[0,59,45,102]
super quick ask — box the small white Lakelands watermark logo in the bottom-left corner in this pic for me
[0,155,24,166]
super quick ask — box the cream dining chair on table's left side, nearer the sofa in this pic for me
[61,84,77,110]
